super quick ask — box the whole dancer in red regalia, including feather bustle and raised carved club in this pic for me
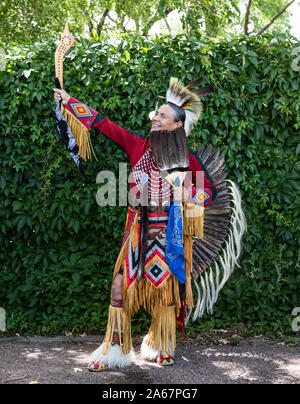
[54,24,246,372]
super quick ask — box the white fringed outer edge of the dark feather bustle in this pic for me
[185,180,247,325]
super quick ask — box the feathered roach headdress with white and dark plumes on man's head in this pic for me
[149,77,214,136]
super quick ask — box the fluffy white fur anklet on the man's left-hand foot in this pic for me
[89,343,135,369]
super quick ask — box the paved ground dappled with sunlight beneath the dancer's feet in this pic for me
[0,335,300,385]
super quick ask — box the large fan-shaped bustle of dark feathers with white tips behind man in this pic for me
[186,145,247,324]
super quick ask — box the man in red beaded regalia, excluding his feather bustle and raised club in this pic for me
[54,73,217,371]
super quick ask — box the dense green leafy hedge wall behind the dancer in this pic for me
[0,31,300,335]
